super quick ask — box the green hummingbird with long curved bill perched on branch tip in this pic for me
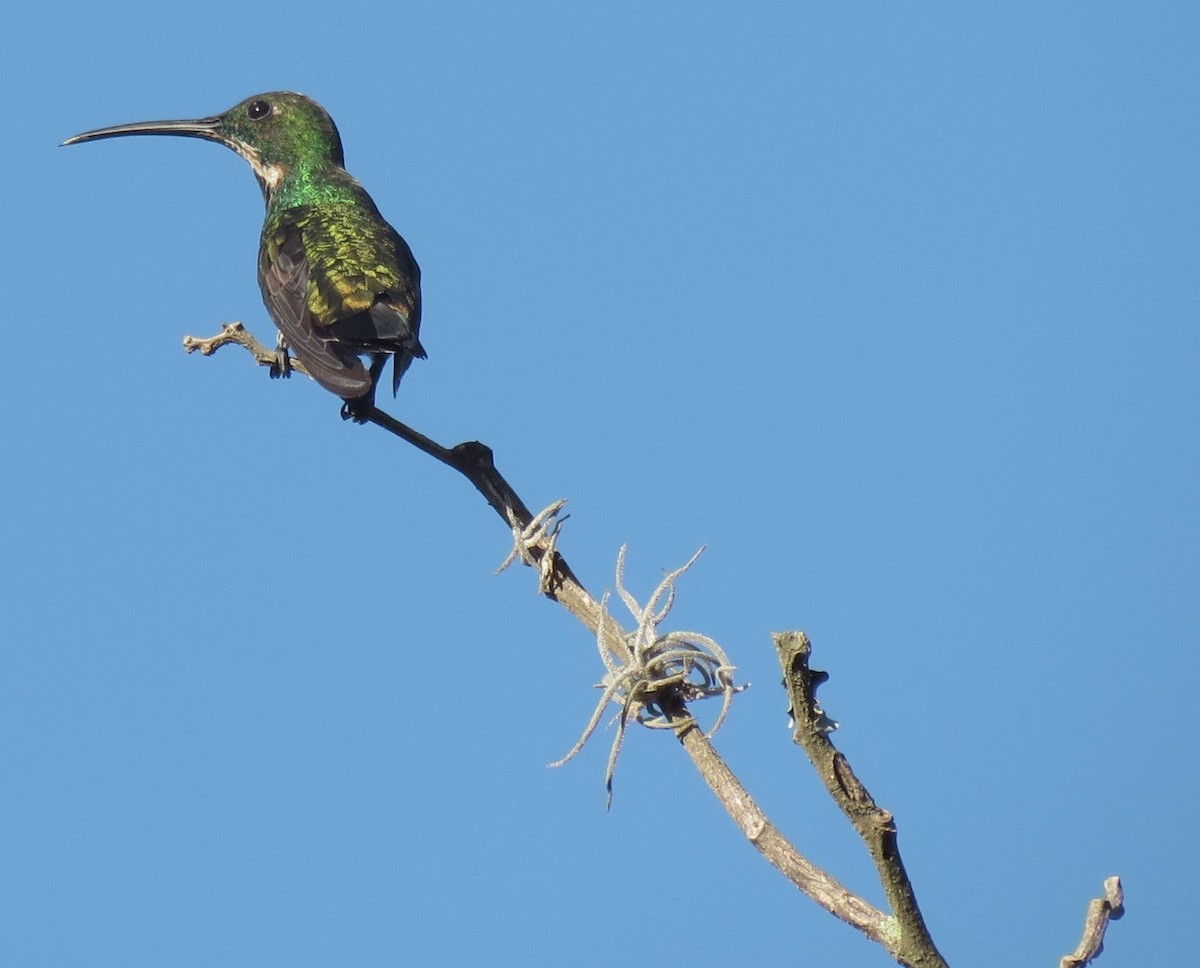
[62,91,425,422]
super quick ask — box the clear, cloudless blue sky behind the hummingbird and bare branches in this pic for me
[0,0,1200,968]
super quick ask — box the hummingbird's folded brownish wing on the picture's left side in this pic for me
[258,220,371,399]
